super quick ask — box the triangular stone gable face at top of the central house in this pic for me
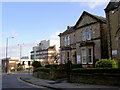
[76,14,97,28]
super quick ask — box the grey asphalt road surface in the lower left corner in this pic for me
[2,72,37,88]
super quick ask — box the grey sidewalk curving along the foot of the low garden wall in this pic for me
[20,74,120,90]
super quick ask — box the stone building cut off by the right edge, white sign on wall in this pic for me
[105,0,120,66]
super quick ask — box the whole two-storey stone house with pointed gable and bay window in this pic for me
[59,11,108,67]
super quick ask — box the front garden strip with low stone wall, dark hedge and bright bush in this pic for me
[32,58,120,86]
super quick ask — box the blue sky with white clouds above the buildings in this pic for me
[0,0,108,59]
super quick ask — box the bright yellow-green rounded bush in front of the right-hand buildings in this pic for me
[95,58,118,68]
